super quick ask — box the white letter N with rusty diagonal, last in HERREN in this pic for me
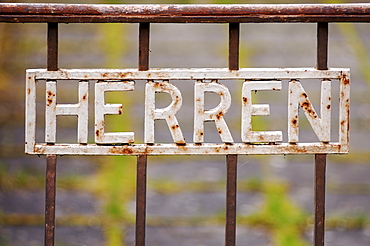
[288,80,331,143]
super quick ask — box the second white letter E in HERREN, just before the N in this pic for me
[242,81,283,143]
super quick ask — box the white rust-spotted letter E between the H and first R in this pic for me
[95,81,135,144]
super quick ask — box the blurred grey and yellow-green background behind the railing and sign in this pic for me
[0,0,370,246]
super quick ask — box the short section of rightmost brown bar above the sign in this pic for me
[316,22,329,70]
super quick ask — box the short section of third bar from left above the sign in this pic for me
[229,23,240,70]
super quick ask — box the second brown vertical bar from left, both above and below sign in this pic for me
[135,23,150,246]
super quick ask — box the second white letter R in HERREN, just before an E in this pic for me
[193,81,234,143]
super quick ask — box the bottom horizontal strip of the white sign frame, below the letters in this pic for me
[27,143,348,155]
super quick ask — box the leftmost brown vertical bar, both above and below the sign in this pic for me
[45,23,58,246]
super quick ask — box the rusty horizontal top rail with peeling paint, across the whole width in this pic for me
[0,3,370,23]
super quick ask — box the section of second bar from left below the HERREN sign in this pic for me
[135,155,147,246]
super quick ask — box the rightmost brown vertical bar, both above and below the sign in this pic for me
[314,22,329,246]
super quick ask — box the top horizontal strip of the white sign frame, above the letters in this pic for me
[27,68,349,80]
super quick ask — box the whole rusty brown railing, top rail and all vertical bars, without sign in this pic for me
[0,3,370,246]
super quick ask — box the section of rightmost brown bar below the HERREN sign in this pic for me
[314,154,326,246]
